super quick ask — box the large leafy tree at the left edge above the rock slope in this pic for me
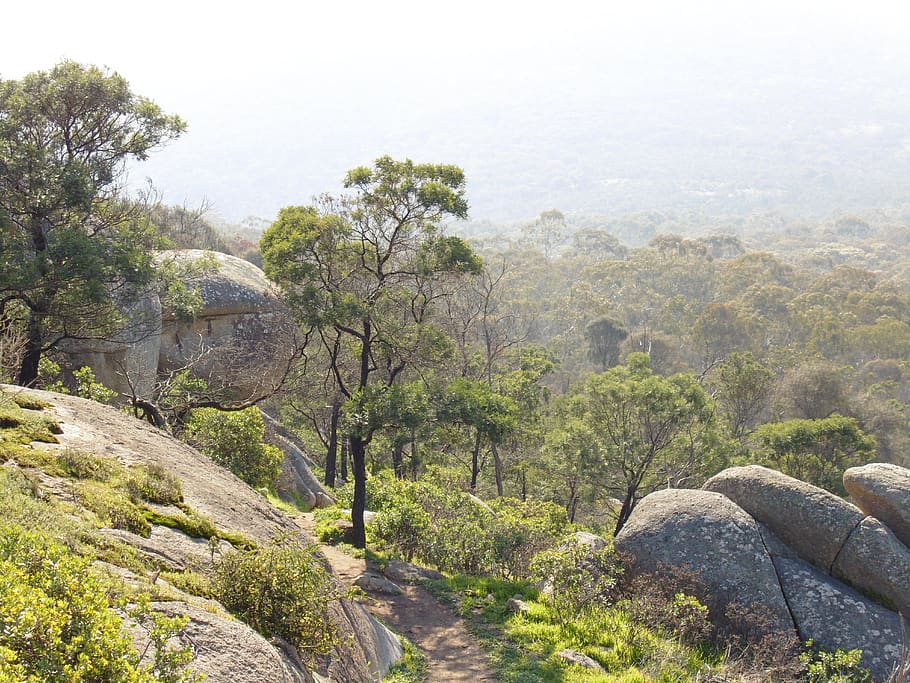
[0,61,185,385]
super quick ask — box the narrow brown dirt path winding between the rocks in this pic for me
[298,514,496,683]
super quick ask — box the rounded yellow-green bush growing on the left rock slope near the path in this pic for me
[212,538,339,662]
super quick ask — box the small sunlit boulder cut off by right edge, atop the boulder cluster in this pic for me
[844,462,910,546]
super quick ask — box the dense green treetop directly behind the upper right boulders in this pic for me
[755,414,875,496]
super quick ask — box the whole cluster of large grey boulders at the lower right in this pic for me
[615,465,910,681]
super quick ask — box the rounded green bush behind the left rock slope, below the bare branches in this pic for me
[184,407,284,488]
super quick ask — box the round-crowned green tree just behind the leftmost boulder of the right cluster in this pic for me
[580,353,722,533]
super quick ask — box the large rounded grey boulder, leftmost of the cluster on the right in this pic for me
[614,489,793,633]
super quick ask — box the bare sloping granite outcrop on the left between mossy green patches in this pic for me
[10,387,401,683]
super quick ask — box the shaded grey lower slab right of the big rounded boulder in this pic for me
[774,558,901,681]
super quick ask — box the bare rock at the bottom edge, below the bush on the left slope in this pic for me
[131,602,313,683]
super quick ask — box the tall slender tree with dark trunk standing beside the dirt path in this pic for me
[261,156,482,548]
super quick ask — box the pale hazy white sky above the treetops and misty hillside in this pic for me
[0,0,910,221]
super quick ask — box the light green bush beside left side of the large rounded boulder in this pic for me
[531,537,622,624]
